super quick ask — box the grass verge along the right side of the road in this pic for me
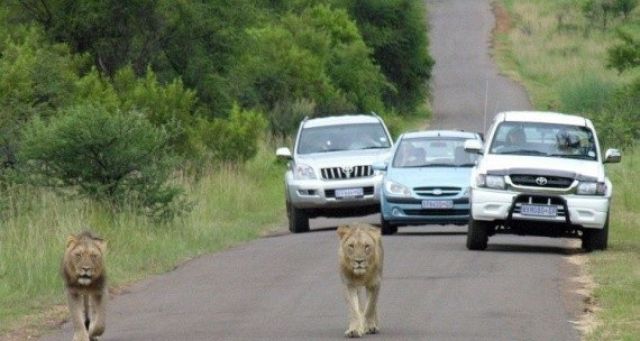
[494,0,640,340]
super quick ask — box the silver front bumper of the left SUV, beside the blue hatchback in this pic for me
[286,175,382,209]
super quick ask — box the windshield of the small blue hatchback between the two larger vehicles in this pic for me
[393,137,478,168]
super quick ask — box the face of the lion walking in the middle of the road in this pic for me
[338,225,380,276]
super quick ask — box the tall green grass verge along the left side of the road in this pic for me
[0,141,285,339]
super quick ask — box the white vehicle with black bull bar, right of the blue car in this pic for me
[465,111,620,251]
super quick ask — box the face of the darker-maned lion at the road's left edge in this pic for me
[64,233,106,286]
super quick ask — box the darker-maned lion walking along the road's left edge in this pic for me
[62,232,107,341]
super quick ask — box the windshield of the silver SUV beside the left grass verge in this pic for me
[298,123,391,154]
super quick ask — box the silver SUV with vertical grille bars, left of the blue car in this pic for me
[276,114,393,233]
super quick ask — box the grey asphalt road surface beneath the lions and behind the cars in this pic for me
[43,0,579,341]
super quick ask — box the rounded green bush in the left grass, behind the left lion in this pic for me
[19,105,181,216]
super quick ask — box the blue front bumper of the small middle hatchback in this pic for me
[380,196,470,225]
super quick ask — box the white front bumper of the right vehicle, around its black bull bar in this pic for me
[471,188,610,229]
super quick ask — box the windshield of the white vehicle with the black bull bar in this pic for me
[489,122,598,160]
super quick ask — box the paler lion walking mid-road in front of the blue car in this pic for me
[338,224,384,337]
